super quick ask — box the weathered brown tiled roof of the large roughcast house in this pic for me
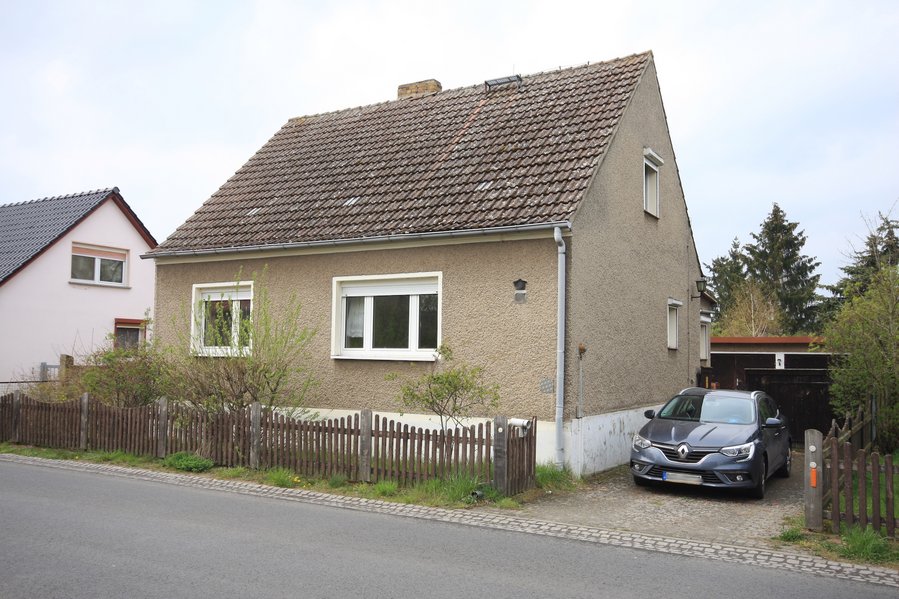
[151,52,652,254]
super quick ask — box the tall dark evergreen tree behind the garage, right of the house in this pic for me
[745,203,821,335]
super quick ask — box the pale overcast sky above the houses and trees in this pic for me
[0,0,899,283]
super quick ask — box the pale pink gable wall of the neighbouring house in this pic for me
[0,200,154,382]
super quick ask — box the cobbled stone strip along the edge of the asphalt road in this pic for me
[0,454,899,588]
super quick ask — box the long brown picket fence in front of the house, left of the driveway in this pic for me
[0,394,536,494]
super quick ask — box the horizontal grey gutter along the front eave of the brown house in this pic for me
[141,221,571,259]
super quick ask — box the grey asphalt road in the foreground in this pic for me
[0,462,896,599]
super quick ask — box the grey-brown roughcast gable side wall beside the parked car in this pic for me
[566,59,699,417]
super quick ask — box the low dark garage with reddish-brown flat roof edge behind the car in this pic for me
[709,337,835,441]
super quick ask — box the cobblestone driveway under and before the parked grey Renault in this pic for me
[486,452,803,547]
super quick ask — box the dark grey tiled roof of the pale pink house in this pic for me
[0,187,119,284]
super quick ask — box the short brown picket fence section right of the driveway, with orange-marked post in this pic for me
[805,410,899,538]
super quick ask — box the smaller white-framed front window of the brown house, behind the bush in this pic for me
[191,283,253,356]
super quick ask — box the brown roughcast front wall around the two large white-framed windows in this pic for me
[156,239,556,419]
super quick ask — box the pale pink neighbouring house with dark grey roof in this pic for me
[0,188,156,391]
